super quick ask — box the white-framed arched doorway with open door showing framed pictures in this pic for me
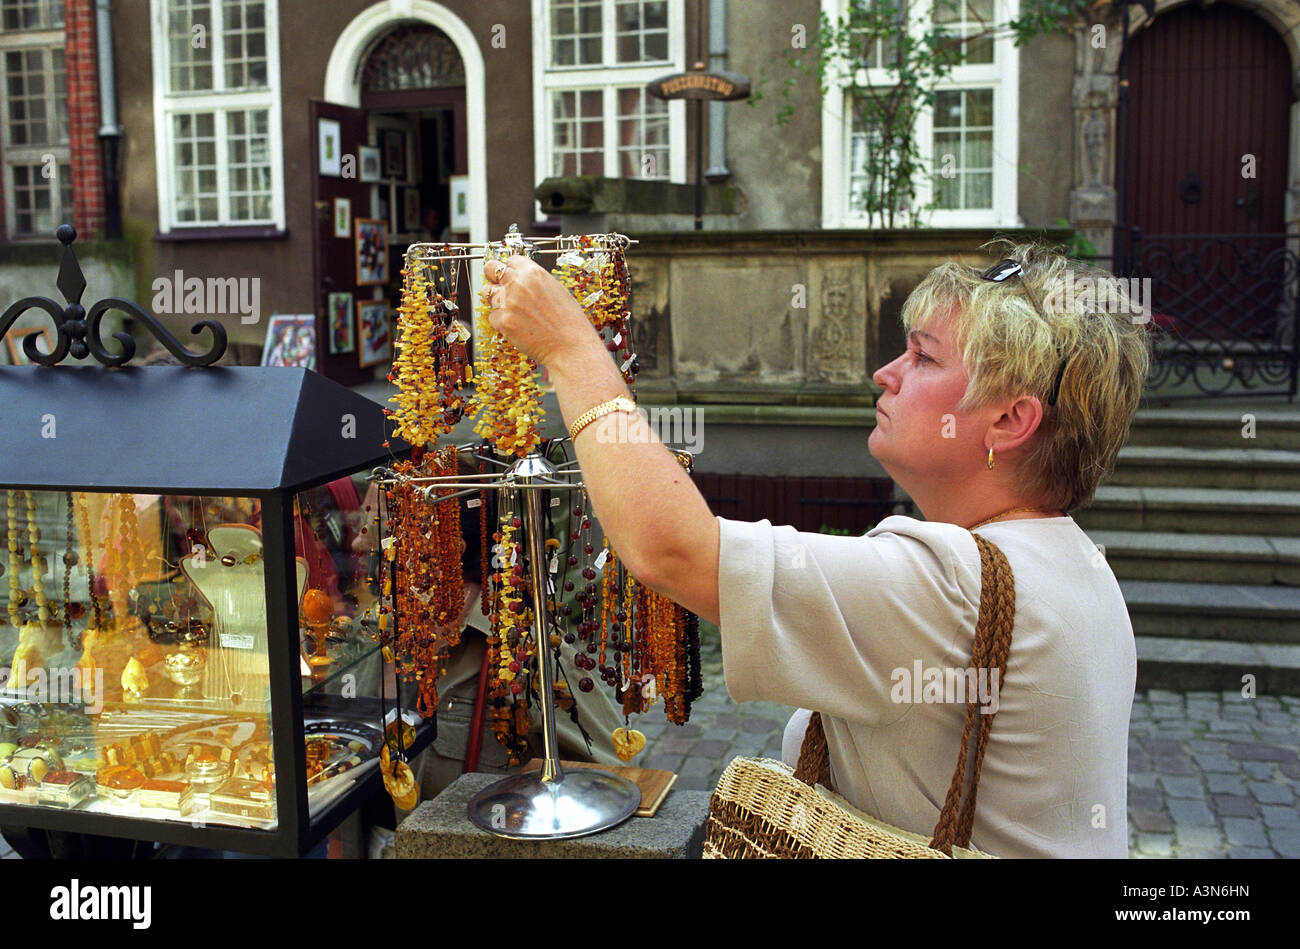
[309,0,488,385]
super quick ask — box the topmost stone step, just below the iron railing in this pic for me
[1128,399,1300,451]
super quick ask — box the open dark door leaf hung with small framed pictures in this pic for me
[308,101,379,386]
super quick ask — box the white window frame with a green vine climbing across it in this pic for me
[822,0,1024,228]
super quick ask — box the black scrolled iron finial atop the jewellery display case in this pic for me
[0,224,226,368]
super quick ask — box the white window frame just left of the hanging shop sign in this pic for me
[532,0,686,220]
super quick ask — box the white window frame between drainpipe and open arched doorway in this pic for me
[150,0,284,234]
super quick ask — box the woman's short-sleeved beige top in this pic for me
[718,516,1138,858]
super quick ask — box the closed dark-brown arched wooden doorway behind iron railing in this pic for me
[1115,3,1300,395]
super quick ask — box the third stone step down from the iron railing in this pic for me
[1073,485,1300,537]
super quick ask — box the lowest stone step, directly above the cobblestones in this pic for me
[1135,636,1300,696]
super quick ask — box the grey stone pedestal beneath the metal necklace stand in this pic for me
[397,774,709,859]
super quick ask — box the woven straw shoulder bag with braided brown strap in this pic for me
[703,534,1015,859]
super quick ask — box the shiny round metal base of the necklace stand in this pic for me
[469,768,641,840]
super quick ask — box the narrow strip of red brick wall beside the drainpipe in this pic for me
[64,0,104,241]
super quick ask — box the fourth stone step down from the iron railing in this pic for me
[1087,528,1300,586]
